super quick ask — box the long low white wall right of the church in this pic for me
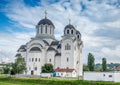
[83,72,120,82]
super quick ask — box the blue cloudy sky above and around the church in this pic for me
[0,0,120,64]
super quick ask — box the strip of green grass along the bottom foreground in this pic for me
[0,76,120,85]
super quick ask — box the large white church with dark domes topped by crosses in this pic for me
[16,12,83,76]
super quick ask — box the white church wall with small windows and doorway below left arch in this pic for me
[27,52,44,75]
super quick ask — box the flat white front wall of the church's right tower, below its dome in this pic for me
[61,39,74,68]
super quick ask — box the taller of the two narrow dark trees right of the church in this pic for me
[88,53,95,71]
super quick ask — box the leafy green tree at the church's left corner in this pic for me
[11,56,26,75]
